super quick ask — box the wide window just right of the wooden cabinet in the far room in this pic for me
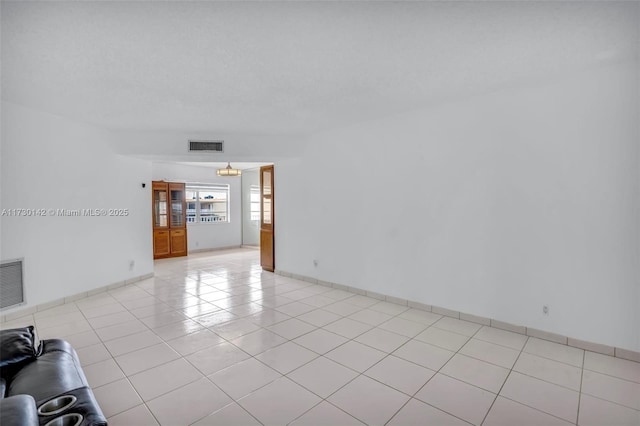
[186,183,229,223]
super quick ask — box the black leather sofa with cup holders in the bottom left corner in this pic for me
[0,326,107,426]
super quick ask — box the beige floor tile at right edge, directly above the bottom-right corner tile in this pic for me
[582,370,640,410]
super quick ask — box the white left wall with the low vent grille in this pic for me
[0,102,153,312]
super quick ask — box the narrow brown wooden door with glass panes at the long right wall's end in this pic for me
[260,166,276,272]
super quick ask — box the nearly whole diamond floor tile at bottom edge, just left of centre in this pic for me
[237,377,321,425]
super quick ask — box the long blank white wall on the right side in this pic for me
[275,63,640,351]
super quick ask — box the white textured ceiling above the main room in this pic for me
[1,1,639,136]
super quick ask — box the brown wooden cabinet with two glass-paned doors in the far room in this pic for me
[152,181,187,259]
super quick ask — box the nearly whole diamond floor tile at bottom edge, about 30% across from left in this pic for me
[147,378,232,425]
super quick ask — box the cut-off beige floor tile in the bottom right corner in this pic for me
[578,394,640,426]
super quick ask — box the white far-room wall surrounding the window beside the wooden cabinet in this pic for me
[149,162,242,250]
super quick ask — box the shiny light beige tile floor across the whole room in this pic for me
[1,249,640,426]
